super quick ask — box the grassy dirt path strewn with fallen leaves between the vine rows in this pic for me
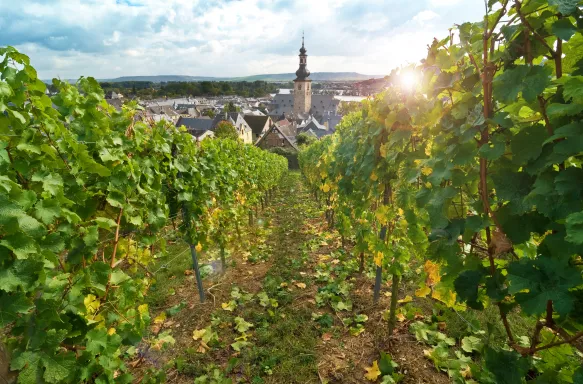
[130,173,448,384]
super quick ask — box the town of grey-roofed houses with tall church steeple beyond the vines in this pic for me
[102,38,387,154]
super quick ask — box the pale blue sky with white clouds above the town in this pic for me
[0,0,484,79]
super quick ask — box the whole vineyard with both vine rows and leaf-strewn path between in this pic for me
[0,0,583,384]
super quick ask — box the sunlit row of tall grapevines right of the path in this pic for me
[300,0,583,382]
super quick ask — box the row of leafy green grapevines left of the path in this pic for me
[0,47,287,384]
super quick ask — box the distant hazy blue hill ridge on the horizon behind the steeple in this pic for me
[100,72,384,83]
